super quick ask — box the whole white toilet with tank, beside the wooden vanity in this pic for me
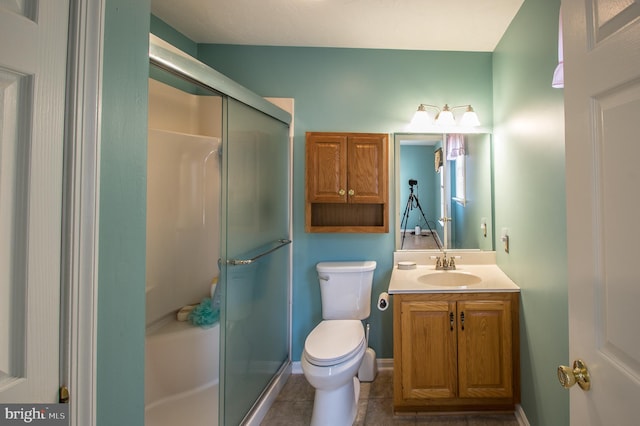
[300,261,376,426]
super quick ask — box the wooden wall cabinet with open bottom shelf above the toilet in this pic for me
[305,132,389,232]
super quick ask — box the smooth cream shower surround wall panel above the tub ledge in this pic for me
[146,126,221,326]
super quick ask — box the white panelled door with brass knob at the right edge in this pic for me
[562,0,640,426]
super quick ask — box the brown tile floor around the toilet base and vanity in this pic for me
[262,370,518,426]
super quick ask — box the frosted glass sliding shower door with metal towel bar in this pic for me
[220,98,291,425]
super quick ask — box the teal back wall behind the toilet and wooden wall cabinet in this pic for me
[198,45,492,360]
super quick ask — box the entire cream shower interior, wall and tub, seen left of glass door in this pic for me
[145,79,222,426]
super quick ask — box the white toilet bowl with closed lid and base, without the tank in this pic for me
[301,320,367,426]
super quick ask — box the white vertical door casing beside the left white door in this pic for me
[61,0,104,426]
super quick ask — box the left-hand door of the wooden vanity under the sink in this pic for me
[400,301,457,399]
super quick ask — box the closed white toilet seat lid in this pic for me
[304,320,366,367]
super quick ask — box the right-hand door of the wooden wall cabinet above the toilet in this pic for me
[347,134,388,204]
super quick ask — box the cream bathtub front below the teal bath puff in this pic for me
[145,318,220,426]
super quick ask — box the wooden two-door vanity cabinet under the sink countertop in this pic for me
[393,292,520,412]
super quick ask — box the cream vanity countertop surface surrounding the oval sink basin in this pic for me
[388,262,520,294]
